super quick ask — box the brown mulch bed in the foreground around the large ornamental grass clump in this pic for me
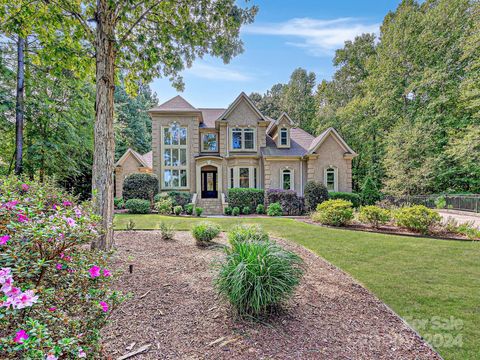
[102,231,440,359]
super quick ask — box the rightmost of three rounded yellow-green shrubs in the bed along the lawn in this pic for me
[395,205,441,234]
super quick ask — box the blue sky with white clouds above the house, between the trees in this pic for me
[151,0,400,107]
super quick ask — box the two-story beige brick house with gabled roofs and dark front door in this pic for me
[115,93,356,213]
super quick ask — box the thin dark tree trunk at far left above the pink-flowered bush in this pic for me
[15,37,25,175]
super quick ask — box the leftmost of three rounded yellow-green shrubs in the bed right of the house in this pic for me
[312,199,353,226]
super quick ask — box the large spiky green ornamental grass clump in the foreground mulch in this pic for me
[214,241,304,317]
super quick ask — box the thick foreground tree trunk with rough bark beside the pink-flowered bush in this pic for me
[92,0,115,250]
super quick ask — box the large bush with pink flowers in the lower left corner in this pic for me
[0,177,122,359]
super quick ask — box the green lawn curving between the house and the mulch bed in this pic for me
[115,214,480,359]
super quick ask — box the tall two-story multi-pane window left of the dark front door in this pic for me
[161,123,188,189]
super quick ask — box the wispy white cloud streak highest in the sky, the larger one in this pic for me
[243,18,380,56]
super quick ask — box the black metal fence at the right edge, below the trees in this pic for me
[389,194,480,213]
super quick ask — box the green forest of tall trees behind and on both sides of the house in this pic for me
[0,0,480,196]
